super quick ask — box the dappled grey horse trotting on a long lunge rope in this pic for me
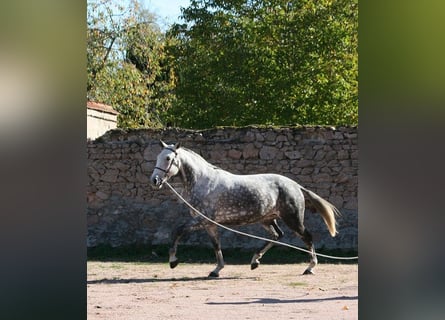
[151,141,340,277]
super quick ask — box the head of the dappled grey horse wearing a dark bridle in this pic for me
[150,140,181,189]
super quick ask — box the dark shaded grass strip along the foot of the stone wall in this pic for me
[87,245,357,264]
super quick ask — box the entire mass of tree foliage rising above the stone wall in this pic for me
[87,0,358,128]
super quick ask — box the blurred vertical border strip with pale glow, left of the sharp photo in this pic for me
[0,0,86,319]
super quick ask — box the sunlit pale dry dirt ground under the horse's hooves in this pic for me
[87,262,358,320]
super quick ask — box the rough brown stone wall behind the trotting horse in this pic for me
[87,127,358,249]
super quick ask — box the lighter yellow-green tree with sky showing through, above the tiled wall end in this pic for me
[87,1,175,128]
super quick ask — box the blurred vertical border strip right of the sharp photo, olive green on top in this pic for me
[359,0,445,319]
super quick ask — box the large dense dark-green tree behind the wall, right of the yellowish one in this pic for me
[166,0,358,128]
